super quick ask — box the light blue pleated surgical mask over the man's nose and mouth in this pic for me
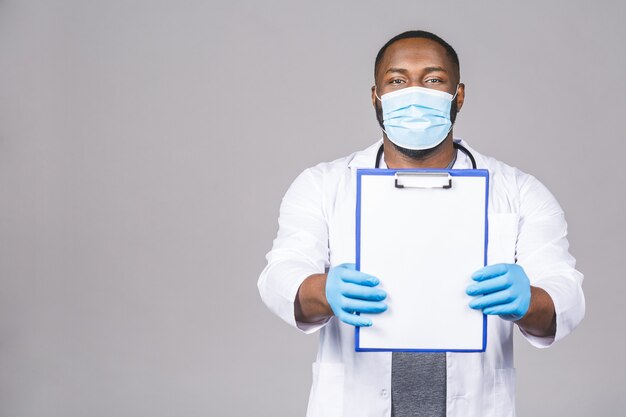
[376,86,458,150]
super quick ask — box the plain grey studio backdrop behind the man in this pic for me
[0,0,626,417]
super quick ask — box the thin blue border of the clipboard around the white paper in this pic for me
[354,168,489,353]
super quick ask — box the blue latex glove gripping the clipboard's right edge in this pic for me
[465,264,530,321]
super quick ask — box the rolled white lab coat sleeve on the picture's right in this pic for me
[516,175,585,348]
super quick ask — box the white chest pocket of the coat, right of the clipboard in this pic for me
[487,213,519,265]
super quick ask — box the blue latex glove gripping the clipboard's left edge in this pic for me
[326,264,387,326]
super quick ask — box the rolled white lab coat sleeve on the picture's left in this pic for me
[258,167,329,333]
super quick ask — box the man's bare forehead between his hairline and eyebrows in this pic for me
[378,38,456,74]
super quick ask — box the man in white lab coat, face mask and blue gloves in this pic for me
[258,31,585,417]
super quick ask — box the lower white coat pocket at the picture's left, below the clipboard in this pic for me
[307,362,345,417]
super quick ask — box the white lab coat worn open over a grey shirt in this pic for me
[258,141,585,417]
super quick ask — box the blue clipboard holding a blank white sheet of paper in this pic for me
[355,169,489,352]
